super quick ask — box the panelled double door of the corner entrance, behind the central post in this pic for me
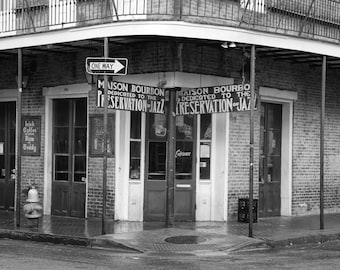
[144,95,197,221]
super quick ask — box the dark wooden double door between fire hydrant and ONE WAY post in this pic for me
[52,98,87,217]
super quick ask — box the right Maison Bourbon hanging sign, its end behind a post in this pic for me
[176,83,256,115]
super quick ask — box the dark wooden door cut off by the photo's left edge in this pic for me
[0,102,16,210]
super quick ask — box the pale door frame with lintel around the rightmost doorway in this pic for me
[259,86,297,216]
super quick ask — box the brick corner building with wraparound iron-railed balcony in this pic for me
[0,0,340,221]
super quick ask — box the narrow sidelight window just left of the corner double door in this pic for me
[129,112,142,180]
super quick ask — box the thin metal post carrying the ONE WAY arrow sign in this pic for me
[102,37,109,234]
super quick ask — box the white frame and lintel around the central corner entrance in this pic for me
[115,71,234,221]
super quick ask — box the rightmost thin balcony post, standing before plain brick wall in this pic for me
[320,56,327,230]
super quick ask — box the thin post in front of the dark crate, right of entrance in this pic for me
[249,45,255,237]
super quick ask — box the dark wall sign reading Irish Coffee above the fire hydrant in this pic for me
[21,116,41,156]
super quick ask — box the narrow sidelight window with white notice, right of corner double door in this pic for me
[199,114,212,180]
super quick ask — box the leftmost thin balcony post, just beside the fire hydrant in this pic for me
[15,49,22,227]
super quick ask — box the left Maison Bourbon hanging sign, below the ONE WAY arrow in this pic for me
[97,80,165,114]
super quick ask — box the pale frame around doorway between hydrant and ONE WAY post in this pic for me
[43,84,91,218]
